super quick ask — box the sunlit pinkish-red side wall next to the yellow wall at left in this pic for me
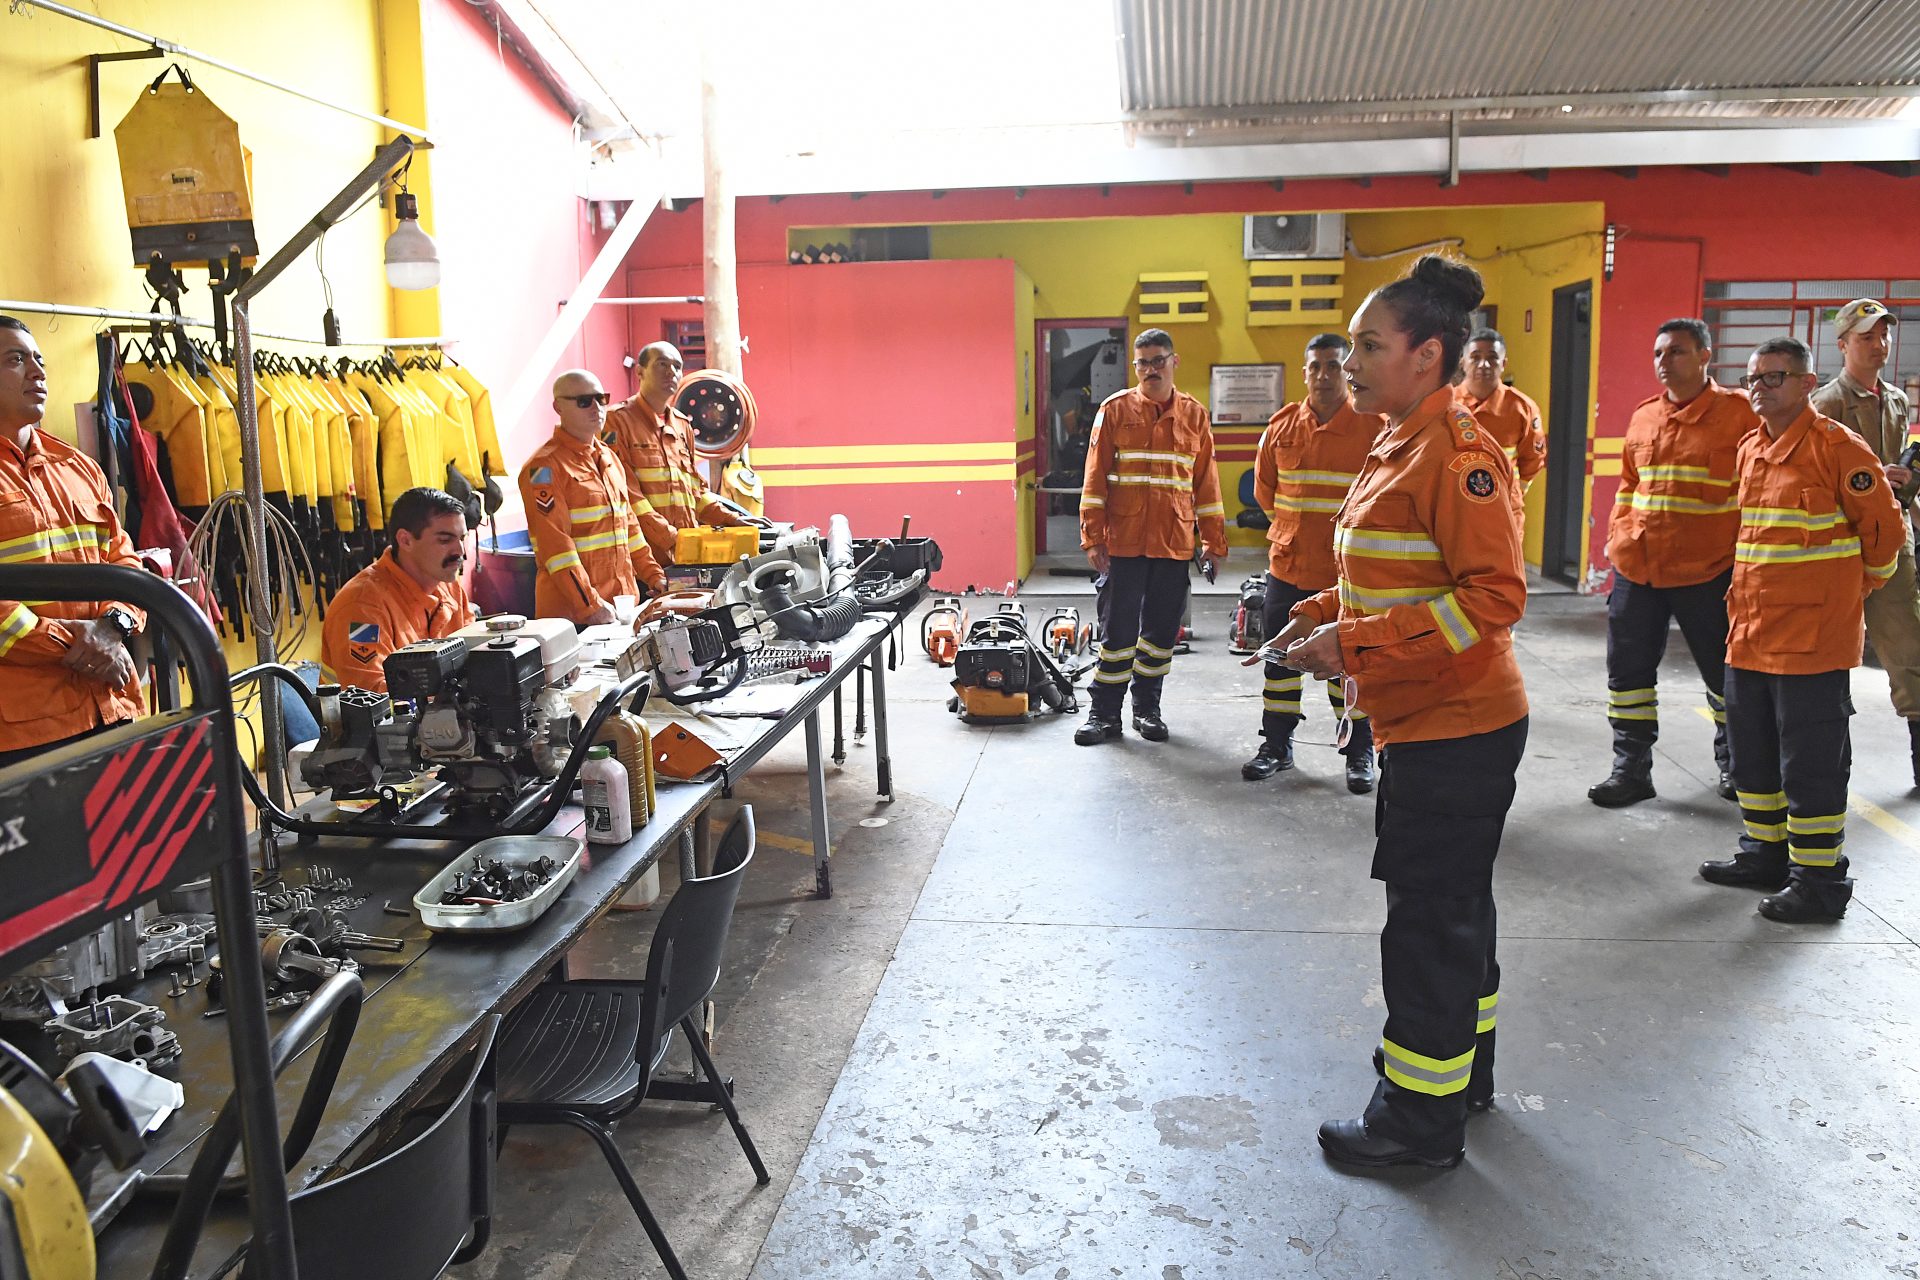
[420,0,625,472]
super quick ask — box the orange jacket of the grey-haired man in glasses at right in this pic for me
[1726,405,1907,676]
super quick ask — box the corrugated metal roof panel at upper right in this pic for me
[1114,0,1920,123]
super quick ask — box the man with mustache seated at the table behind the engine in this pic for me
[321,489,474,693]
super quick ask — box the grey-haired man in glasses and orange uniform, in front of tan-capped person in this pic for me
[1699,338,1907,925]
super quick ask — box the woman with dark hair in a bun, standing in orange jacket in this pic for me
[1275,255,1526,1169]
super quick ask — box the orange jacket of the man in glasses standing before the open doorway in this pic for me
[1081,388,1227,560]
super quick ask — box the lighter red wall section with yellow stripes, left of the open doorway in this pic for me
[628,259,1020,589]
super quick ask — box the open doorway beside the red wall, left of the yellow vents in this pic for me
[1033,319,1129,555]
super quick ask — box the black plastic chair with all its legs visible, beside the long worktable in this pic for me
[499,806,770,1280]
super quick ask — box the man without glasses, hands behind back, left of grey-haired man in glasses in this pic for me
[1586,319,1761,808]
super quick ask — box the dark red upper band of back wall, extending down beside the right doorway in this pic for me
[628,165,1920,587]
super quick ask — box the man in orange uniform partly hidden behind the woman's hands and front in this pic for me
[1240,334,1384,794]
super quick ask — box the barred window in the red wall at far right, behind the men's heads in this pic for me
[1701,278,1920,420]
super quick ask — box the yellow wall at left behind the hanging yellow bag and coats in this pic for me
[0,0,440,756]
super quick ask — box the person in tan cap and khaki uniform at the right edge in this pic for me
[1812,297,1920,785]
